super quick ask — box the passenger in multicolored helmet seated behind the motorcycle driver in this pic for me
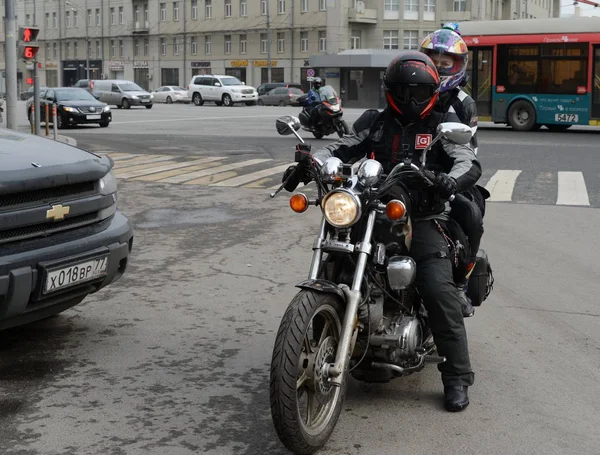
[421,23,489,317]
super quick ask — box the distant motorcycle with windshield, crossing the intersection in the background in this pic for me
[297,85,350,139]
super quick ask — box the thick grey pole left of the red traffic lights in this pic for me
[4,0,17,130]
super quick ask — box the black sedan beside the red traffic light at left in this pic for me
[26,87,112,128]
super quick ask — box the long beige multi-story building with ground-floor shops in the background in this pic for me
[0,0,560,106]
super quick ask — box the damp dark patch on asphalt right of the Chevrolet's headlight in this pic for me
[135,208,238,229]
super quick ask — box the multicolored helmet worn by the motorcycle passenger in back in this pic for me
[421,28,469,92]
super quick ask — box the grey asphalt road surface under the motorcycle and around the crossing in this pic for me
[0,101,600,455]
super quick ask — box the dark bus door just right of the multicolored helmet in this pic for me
[464,47,494,120]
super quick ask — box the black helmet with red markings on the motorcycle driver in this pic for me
[383,51,440,123]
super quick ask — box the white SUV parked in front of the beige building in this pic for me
[188,74,258,106]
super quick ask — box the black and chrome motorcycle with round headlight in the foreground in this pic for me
[270,116,491,454]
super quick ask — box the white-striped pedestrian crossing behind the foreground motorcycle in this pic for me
[96,151,600,207]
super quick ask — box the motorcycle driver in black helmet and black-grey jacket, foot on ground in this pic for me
[283,51,481,411]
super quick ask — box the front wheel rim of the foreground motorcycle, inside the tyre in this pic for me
[296,305,341,435]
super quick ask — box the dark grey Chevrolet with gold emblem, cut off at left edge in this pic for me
[0,129,134,330]
